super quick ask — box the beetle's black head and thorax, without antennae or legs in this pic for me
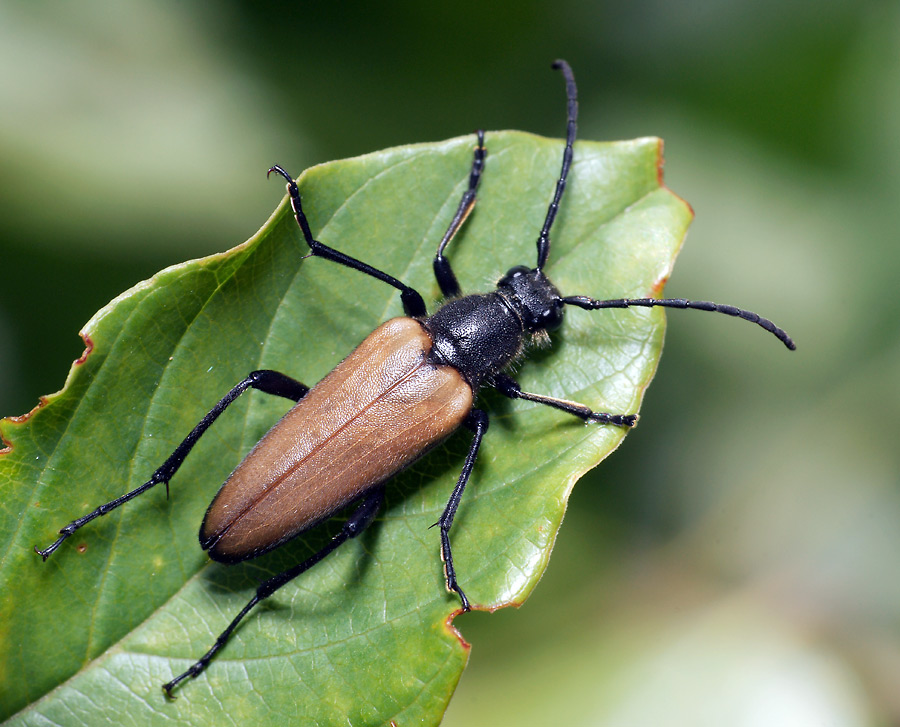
[424,267,562,390]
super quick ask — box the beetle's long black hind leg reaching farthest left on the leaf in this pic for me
[34,370,309,560]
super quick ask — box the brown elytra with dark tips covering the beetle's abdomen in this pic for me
[200,318,473,563]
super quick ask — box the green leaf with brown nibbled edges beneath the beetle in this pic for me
[0,132,691,726]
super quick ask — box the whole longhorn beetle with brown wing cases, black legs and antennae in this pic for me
[35,60,795,697]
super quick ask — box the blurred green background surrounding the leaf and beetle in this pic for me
[0,0,900,727]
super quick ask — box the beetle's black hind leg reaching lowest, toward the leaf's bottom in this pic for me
[163,487,384,699]
